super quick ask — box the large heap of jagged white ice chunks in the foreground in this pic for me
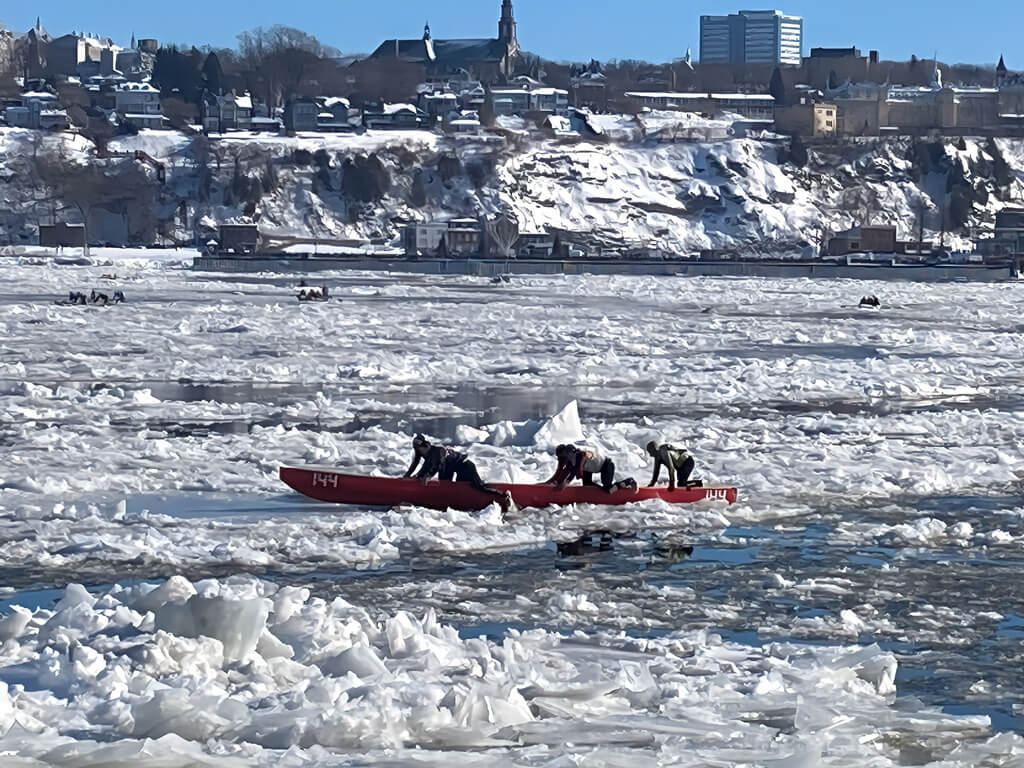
[0,578,1024,768]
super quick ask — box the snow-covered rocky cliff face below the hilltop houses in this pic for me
[0,123,1024,256]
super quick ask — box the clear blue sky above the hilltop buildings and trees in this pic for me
[6,0,1024,69]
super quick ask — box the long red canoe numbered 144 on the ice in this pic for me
[280,467,736,512]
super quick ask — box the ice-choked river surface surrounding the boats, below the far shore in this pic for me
[0,259,1024,768]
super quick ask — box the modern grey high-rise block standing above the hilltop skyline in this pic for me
[700,10,804,66]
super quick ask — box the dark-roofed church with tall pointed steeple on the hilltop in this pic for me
[370,0,519,84]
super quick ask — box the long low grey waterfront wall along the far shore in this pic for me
[193,256,1017,283]
